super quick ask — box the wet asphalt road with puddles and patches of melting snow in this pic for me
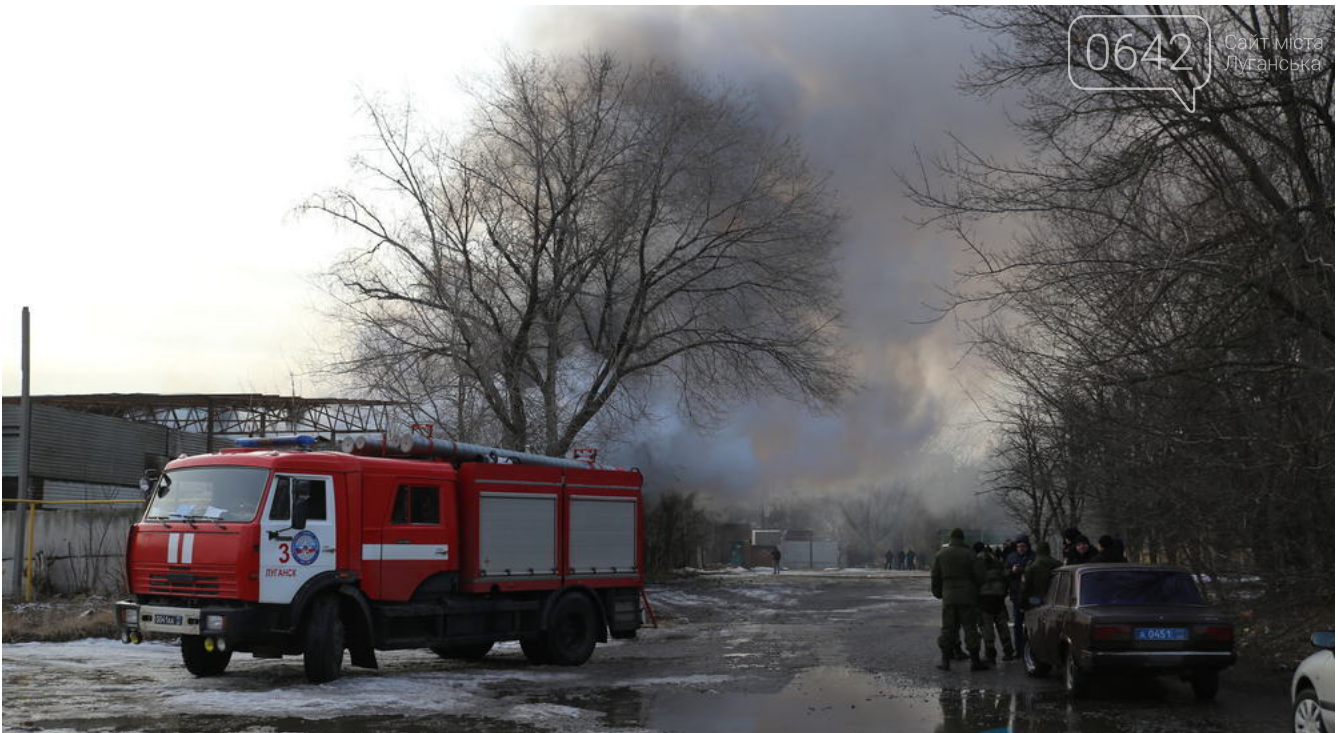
[3,574,1290,733]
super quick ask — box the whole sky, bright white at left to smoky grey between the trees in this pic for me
[0,4,1016,510]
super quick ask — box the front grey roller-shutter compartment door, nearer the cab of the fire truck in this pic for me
[479,492,558,578]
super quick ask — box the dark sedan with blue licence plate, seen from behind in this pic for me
[1024,563,1236,701]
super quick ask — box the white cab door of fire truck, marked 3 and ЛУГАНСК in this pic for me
[260,474,339,603]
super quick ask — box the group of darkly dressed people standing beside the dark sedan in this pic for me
[930,527,1128,671]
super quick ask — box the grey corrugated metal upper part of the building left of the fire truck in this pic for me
[3,404,219,486]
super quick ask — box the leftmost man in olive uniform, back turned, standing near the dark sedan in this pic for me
[930,528,989,671]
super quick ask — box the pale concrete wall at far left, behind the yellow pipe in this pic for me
[4,507,143,595]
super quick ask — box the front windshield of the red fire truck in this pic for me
[145,465,269,522]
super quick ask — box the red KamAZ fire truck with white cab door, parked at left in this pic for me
[116,436,642,682]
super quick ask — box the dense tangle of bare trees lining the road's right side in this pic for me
[909,7,1334,605]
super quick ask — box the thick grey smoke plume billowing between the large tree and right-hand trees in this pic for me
[523,8,1017,508]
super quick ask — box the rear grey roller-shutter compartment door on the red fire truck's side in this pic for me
[567,496,637,575]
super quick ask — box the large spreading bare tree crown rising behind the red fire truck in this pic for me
[304,54,848,455]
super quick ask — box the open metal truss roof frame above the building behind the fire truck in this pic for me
[4,393,400,451]
